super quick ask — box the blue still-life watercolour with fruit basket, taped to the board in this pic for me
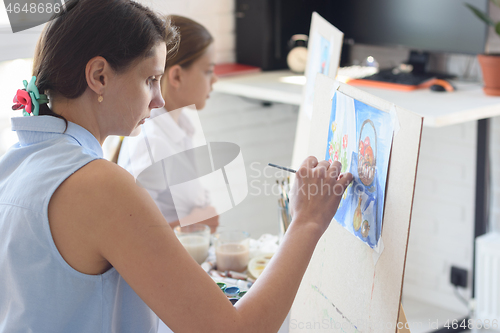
[325,91,394,251]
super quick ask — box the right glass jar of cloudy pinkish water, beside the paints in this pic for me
[214,231,250,272]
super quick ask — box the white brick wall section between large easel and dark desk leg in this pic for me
[403,122,477,314]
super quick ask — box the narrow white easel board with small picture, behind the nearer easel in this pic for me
[292,12,344,167]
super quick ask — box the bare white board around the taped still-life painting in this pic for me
[290,74,423,333]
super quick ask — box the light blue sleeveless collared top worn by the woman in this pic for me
[0,116,158,333]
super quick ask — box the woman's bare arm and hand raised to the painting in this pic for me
[49,157,352,333]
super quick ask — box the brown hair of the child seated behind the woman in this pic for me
[165,15,214,68]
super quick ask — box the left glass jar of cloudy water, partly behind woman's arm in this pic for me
[174,223,210,264]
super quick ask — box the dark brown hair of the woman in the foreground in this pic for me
[33,0,179,119]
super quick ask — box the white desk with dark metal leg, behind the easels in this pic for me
[214,71,500,330]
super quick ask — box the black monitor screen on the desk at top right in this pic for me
[341,0,488,54]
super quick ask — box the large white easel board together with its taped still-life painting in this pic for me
[289,74,423,333]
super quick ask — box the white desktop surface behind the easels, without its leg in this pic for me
[214,71,500,127]
